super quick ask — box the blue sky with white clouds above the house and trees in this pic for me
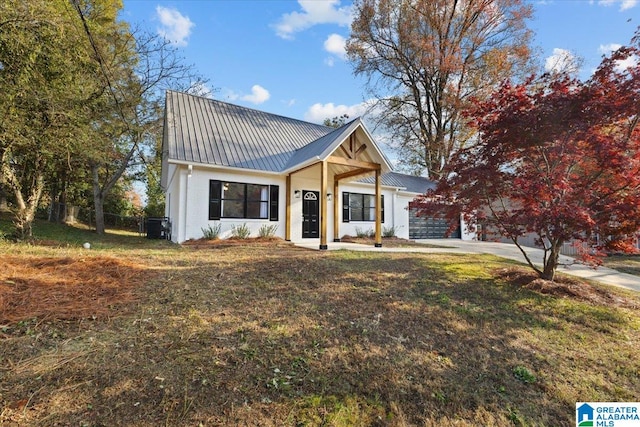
[121,0,640,123]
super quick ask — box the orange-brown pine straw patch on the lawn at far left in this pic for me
[0,256,148,324]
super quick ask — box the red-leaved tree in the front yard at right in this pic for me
[418,29,640,280]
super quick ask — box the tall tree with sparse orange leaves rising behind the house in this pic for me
[346,0,532,179]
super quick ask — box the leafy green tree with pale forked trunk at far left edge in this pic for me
[0,0,89,239]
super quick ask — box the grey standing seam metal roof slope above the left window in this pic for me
[166,91,330,172]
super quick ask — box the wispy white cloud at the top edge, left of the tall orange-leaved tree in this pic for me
[273,0,353,40]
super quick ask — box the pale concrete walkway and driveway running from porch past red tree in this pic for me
[297,239,640,292]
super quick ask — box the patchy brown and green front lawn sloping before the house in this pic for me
[0,242,640,426]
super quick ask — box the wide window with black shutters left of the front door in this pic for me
[209,180,279,221]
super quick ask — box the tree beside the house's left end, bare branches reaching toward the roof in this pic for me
[73,0,203,234]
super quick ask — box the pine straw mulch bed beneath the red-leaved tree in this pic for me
[495,267,639,309]
